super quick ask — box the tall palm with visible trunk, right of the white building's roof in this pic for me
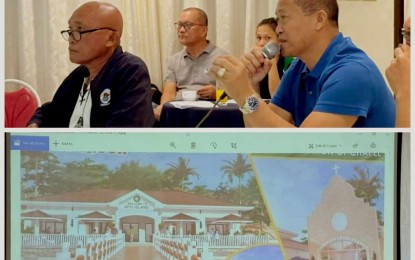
[220,153,252,205]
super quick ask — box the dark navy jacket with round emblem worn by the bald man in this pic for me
[28,47,155,127]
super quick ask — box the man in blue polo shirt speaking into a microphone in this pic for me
[210,0,396,127]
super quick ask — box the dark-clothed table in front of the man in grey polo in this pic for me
[160,100,245,128]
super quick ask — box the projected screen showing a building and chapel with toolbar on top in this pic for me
[6,130,398,260]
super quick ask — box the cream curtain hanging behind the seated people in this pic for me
[4,0,277,102]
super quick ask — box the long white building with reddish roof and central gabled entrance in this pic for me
[21,189,253,243]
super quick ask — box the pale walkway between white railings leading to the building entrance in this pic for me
[111,243,166,260]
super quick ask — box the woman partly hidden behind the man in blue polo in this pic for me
[254,18,294,99]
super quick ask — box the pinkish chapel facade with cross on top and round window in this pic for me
[307,165,383,260]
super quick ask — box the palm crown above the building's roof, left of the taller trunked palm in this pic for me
[165,157,199,190]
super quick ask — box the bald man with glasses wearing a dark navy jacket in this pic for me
[28,1,155,128]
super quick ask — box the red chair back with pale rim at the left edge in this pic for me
[4,79,41,127]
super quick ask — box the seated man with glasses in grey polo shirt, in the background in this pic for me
[154,7,227,119]
